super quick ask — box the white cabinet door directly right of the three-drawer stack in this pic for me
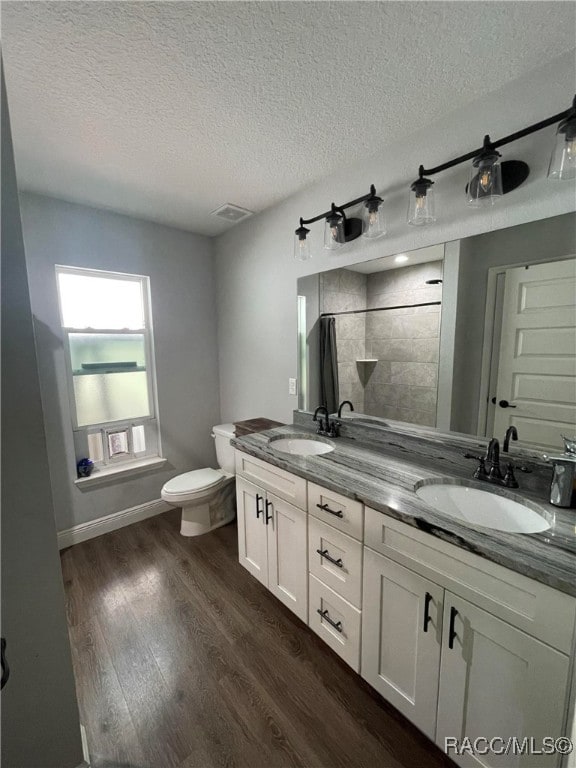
[361,549,444,739]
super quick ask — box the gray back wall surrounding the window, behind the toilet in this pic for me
[21,194,220,530]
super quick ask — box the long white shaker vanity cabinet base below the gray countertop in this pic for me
[236,451,576,768]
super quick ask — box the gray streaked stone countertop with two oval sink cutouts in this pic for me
[232,419,576,596]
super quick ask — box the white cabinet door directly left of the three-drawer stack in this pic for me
[264,493,308,622]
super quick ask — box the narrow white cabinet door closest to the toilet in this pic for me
[236,477,268,587]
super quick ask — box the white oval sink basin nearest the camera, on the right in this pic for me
[416,483,550,533]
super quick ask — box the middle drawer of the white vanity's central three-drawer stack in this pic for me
[308,517,362,608]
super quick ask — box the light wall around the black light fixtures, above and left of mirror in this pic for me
[216,53,575,422]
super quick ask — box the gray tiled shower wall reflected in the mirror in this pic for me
[320,261,442,426]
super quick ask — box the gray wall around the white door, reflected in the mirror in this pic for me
[451,214,576,434]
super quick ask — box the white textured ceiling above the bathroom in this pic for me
[2,1,576,235]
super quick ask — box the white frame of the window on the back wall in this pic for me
[55,264,162,467]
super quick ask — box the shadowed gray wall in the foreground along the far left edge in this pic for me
[2,63,82,768]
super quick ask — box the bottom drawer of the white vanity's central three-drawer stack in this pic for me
[308,574,361,672]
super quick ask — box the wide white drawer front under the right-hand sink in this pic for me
[365,507,576,653]
